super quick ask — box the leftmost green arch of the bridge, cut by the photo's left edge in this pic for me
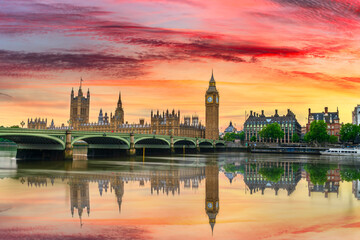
[0,133,65,150]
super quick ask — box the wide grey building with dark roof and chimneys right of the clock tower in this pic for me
[244,109,301,143]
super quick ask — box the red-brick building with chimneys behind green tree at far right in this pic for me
[306,107,340,137]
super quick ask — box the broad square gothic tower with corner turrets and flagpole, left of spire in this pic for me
[70,79,90,128]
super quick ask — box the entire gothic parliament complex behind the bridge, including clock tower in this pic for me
[28,73,219,140]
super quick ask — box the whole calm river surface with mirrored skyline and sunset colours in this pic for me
[0,151,360,239]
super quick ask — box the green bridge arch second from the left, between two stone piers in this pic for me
[71,135,130,148]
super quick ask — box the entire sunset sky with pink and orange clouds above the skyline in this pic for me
[0,0,360,130]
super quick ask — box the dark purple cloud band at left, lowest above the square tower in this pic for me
[0,50,146,78]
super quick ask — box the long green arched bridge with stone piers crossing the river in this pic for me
[0,128,225,159]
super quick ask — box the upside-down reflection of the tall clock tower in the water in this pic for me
[205,163,219,232]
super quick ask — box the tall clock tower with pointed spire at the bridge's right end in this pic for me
[205,72,219,140]
